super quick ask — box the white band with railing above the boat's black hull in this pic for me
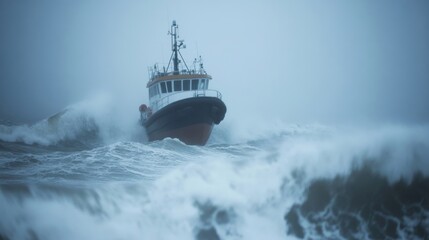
[152,89,222,112]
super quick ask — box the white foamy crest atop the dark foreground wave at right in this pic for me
[274,126,429,182]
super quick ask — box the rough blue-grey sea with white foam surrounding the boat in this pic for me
[0,106,429,240]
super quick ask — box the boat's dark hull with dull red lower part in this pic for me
[144,97,226,145]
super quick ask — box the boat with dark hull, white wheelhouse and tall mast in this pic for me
[139,21,226,145]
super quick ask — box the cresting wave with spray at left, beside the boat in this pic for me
[0,96,145,149]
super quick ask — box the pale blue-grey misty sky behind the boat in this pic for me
[0,0,429,123]
